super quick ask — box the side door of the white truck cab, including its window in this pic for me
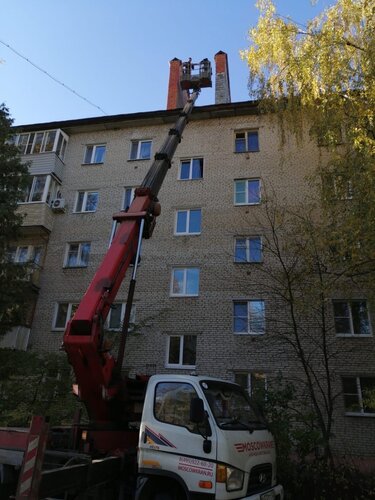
[140,381,217,493]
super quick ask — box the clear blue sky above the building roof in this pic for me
[0,0,334,125]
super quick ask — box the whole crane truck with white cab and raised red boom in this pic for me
[0,59,283,500]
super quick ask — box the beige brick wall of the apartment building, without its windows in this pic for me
[11,99,375,458]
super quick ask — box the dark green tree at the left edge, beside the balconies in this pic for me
[0,104,28,335]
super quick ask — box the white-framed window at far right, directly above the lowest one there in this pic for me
[333,300,371,335]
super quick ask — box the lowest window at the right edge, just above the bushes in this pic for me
[342,377,375,416]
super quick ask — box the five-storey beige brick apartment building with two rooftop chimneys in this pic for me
[6,52,375,459]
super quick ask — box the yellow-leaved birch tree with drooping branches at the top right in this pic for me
[241,0,375,262]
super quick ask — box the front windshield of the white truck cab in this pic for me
[201,380,267,431]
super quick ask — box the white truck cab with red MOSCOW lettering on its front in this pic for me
[137,375,283,500]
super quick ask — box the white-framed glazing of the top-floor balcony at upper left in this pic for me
[15,130,68,159]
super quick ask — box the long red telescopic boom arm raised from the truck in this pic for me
[63,60,211,423]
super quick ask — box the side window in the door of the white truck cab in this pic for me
[154,382,198,433]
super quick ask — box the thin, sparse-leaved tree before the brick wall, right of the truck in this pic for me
[228,189,374,465]
